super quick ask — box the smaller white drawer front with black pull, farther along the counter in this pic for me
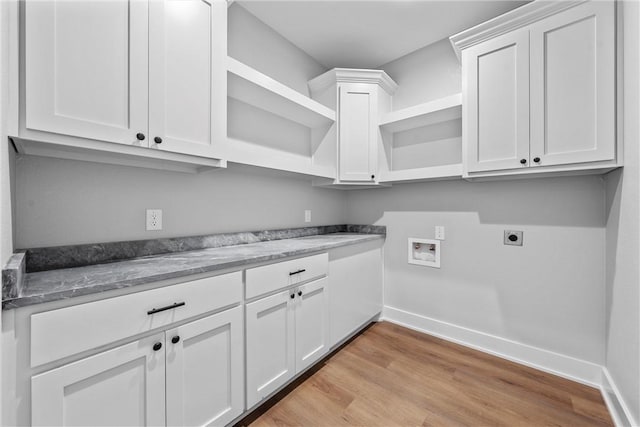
[246,253,329,299]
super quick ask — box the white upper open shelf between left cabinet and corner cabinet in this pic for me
[227,57,336,128]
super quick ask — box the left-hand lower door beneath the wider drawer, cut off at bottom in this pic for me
[31,333,165,426]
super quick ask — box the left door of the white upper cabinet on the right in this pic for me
[462,29,529,172]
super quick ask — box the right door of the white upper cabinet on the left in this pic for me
[149,0,227,157]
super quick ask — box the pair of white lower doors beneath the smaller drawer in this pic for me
[246,278,329,408]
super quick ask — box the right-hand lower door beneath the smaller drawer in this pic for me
[295,278,329,372]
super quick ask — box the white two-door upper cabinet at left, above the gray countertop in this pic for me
[22,0,227,166]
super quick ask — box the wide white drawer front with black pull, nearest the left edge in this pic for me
[31,272,242,367]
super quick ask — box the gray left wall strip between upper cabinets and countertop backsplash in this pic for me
[15,156,346,248]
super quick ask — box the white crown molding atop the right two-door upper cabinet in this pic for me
[449,0,592,60]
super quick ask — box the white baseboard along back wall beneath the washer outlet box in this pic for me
[382,306,602,388]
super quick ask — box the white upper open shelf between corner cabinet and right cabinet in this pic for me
[380,93,462,133]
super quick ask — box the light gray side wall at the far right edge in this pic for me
[606,1,640,423]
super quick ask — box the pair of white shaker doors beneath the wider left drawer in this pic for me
[31,307,244,426]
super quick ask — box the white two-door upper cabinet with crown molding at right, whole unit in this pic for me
[451,1,622,177]
